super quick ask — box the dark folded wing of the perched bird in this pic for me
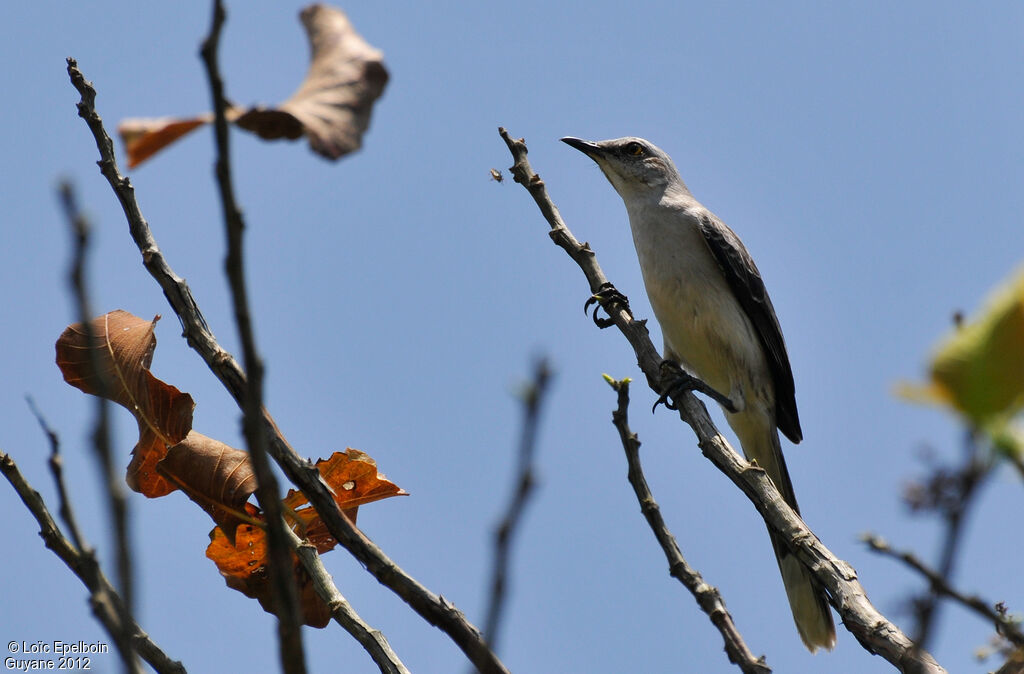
[698,209,804,443]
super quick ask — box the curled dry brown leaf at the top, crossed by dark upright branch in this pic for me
[118,5,388,168]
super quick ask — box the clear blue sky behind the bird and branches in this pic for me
[0,0,1024,673]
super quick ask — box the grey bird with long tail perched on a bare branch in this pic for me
[561,136,836,652]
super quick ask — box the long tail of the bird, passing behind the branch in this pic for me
[737,419,836,652]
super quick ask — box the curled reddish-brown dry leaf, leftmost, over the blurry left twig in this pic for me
[56,309,196,473]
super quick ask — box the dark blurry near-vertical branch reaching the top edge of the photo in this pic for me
[201,0,306,673]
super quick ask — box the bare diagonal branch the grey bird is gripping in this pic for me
[499,128,945,673]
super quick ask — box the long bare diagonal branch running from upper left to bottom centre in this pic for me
[68,58,507,672]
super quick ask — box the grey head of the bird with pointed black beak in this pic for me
[562,136,686,201]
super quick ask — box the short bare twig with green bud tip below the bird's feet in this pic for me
[607,377,771,674]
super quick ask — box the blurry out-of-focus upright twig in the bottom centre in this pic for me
[483,359,551,651]
